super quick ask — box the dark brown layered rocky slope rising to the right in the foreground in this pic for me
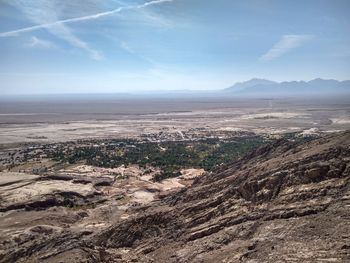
[0,132,350,263]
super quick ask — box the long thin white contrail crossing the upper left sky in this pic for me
[0,0,174,37]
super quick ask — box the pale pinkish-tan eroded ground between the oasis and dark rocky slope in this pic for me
[0,165,203,248]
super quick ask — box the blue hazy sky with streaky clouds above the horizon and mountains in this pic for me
[0,0,350,96]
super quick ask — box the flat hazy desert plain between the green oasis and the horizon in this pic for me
[0,98,350,144]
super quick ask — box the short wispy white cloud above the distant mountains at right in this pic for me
[260,35,313,61]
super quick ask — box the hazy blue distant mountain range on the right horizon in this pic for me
[225,78,350,96]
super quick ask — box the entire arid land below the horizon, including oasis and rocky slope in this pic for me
[0,98,350,262]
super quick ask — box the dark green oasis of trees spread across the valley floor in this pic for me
[46,136,267,181]
